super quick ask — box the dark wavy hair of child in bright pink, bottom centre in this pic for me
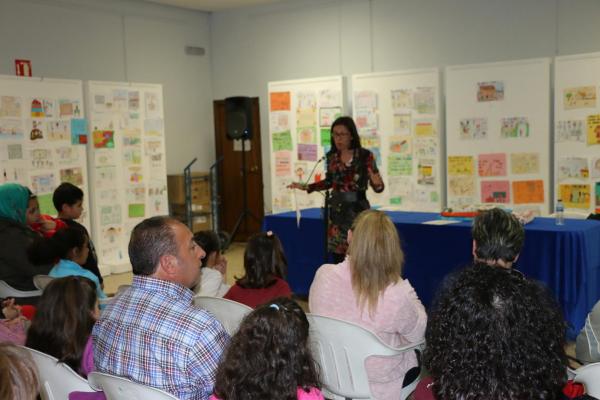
[214,298,320,400]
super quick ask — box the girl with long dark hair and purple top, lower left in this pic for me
[25,276,104,400]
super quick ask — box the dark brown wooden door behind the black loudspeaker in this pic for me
[213,97,264,241]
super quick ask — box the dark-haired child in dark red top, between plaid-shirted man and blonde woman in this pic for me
[223,231,292,308]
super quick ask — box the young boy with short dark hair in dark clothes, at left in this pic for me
[52,182,103,286]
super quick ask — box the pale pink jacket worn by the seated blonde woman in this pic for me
[308,257,427,400]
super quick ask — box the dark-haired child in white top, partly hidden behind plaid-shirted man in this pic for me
[193,231,231,297]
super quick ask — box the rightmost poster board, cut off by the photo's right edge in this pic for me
[554,53,600,214]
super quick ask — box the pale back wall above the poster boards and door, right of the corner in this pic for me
[210,0,600,210]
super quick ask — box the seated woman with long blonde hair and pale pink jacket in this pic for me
[308,210,427,400]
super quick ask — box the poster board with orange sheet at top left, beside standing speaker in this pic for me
[268,76,345,213]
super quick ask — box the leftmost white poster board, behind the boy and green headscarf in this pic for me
[0,75,90,225]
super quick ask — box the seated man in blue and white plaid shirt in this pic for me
[92,217,229,399]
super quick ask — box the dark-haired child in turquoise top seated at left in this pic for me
[28,226,106,299]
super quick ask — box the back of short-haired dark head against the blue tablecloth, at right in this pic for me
[471,208,525,268]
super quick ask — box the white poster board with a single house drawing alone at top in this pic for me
[446,58,551,215]
